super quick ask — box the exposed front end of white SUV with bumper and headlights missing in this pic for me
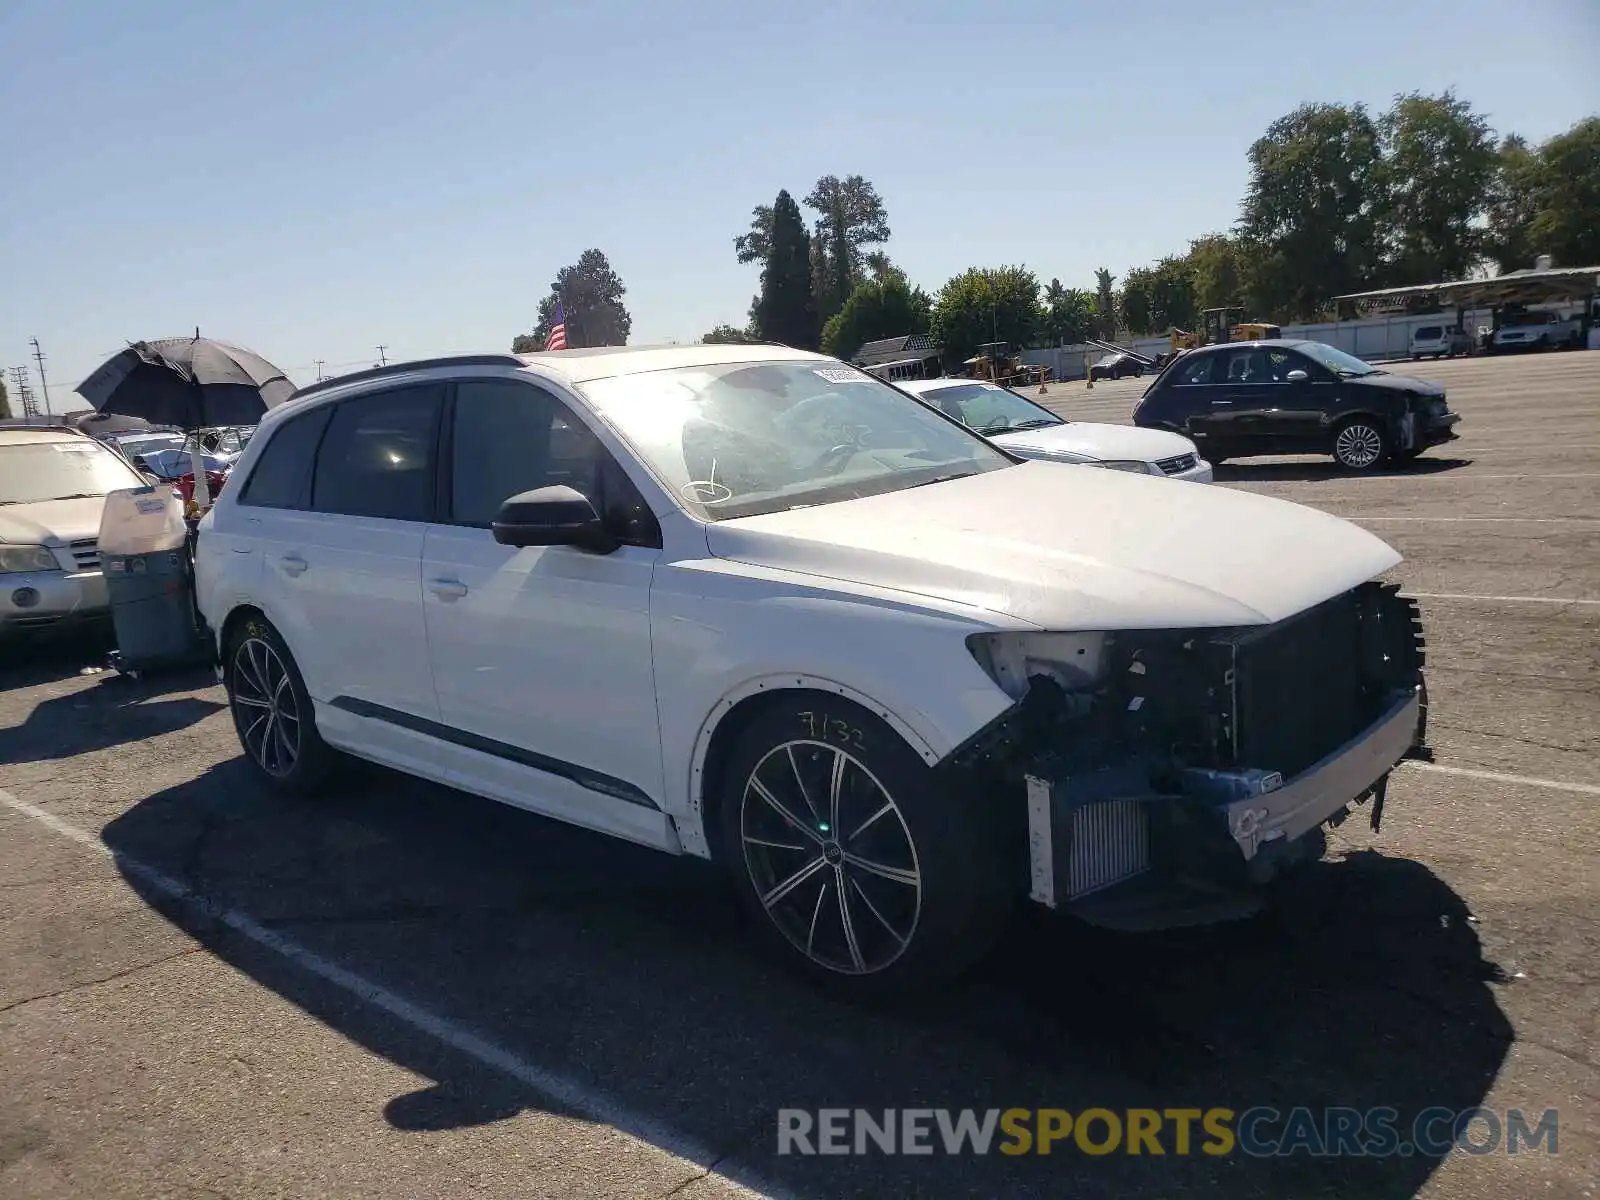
[947,582,1429,930]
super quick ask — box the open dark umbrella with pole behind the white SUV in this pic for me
[77,330,294,506]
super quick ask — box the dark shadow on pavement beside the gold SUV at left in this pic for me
[0,664,227,763]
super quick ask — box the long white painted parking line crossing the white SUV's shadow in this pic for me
[0,789,782,1197]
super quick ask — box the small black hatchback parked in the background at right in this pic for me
[1133,339,1461,470]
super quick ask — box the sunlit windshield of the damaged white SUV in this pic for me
[581,358,1013,520]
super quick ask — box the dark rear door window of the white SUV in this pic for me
[310,384,445,522]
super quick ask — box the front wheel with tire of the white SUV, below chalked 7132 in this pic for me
[720,696,1013,1000]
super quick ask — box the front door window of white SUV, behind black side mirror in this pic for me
[450,379,661,546]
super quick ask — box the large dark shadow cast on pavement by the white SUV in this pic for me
[104,760,1512,1197]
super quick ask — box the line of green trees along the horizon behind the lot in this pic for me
[512,91,1600,362]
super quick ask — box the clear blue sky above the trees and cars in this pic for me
[0,0,1600,411]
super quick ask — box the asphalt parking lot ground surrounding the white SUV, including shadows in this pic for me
[0,354,1600,1200]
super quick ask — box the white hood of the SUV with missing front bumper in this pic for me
[706,462,1400,630]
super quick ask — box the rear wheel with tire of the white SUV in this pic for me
[222,616,333,794]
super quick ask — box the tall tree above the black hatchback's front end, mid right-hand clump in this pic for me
[1378,91,1496,285]
